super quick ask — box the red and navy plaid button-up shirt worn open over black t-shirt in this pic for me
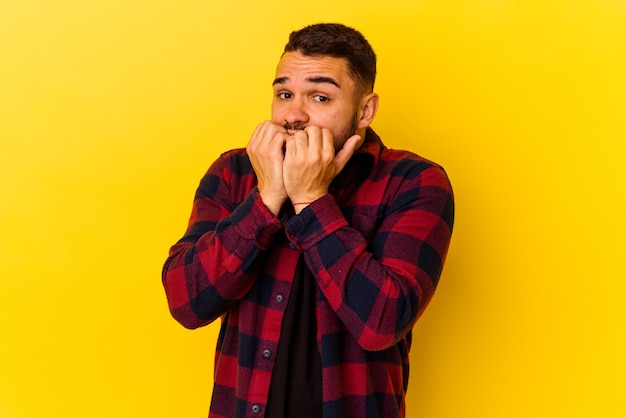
[163,129,454,418]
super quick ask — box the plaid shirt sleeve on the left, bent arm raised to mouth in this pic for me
[162,155,283,328]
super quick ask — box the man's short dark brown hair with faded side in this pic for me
[283,23,376,93]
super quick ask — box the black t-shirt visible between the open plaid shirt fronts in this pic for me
[265,256,322,418]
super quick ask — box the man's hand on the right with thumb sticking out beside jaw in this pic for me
[283,126,361,212]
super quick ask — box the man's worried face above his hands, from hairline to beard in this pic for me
[272,51,357,150]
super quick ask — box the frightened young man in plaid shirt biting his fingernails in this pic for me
[163,24,454,418]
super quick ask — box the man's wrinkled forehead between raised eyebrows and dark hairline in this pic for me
[276,51,354,88]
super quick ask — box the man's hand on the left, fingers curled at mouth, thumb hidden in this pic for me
[246,121,289,215]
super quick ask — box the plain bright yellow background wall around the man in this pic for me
[0,0,626,418]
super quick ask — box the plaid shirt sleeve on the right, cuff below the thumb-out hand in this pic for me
[286,165,454,351]
